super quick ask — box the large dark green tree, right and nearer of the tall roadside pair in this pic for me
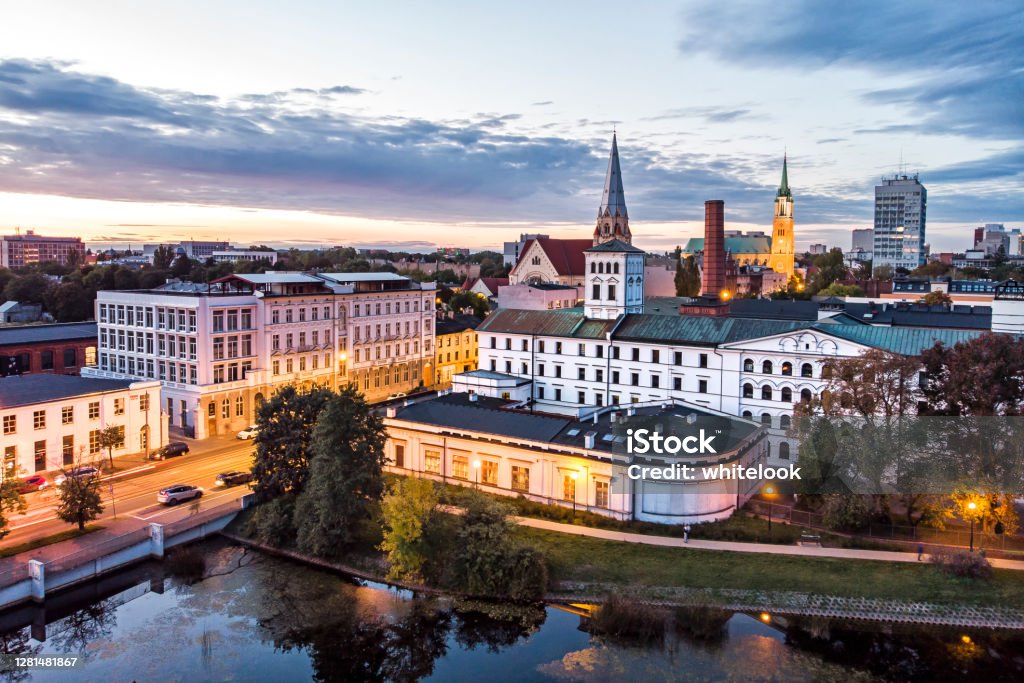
[295,385,387,556]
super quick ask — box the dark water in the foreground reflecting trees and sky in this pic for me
[0,541,1024,683]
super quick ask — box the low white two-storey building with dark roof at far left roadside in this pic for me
[0,375,168,477]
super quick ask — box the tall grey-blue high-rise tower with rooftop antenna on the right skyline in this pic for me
[871,174,928,270]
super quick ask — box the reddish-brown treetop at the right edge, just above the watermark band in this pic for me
[921,332,1024,416]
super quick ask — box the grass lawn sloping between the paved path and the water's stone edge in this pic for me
[516,527,1024,607]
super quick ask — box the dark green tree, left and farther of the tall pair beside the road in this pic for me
[252,386,334,503]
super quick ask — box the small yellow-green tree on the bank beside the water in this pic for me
[380,479,437,581]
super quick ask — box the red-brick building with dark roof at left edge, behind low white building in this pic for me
[0,323,96,377]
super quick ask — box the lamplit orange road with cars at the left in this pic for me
[0,438,254,548]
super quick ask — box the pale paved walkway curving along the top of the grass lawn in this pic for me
[515,517,1024,571]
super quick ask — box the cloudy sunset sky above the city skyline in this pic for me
[0,0,1024,251]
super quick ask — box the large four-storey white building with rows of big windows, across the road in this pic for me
[84,272,435,438]
